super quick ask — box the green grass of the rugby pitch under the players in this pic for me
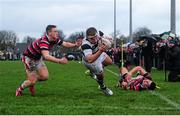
[0,61,180,115]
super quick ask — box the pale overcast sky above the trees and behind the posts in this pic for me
[0,0,180,40]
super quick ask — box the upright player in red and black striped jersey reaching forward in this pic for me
[16,25,81,96]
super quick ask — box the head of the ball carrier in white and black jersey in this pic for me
[86,27,99,44]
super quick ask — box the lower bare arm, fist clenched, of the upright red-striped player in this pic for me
[41,50,68,64]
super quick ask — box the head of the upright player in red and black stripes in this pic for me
[46,25,58,40]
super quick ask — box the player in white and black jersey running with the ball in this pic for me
[81,27,113,95]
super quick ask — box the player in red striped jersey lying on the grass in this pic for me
[117,66,156,91]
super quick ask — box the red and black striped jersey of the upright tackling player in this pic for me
[23,35,63,60]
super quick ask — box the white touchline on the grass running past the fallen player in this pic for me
[105,68,180,110]
